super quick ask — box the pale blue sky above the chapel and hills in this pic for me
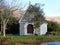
[3,0,60,16]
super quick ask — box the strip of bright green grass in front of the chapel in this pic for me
[0,35,60,42]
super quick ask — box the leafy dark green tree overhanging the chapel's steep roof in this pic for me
[24,4,45,28]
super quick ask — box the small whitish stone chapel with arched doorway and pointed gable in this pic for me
[19,13,47,35]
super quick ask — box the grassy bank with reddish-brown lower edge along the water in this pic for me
[0,35,60,44]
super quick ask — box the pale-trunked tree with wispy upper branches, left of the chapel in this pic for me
[0,0,21,36]
